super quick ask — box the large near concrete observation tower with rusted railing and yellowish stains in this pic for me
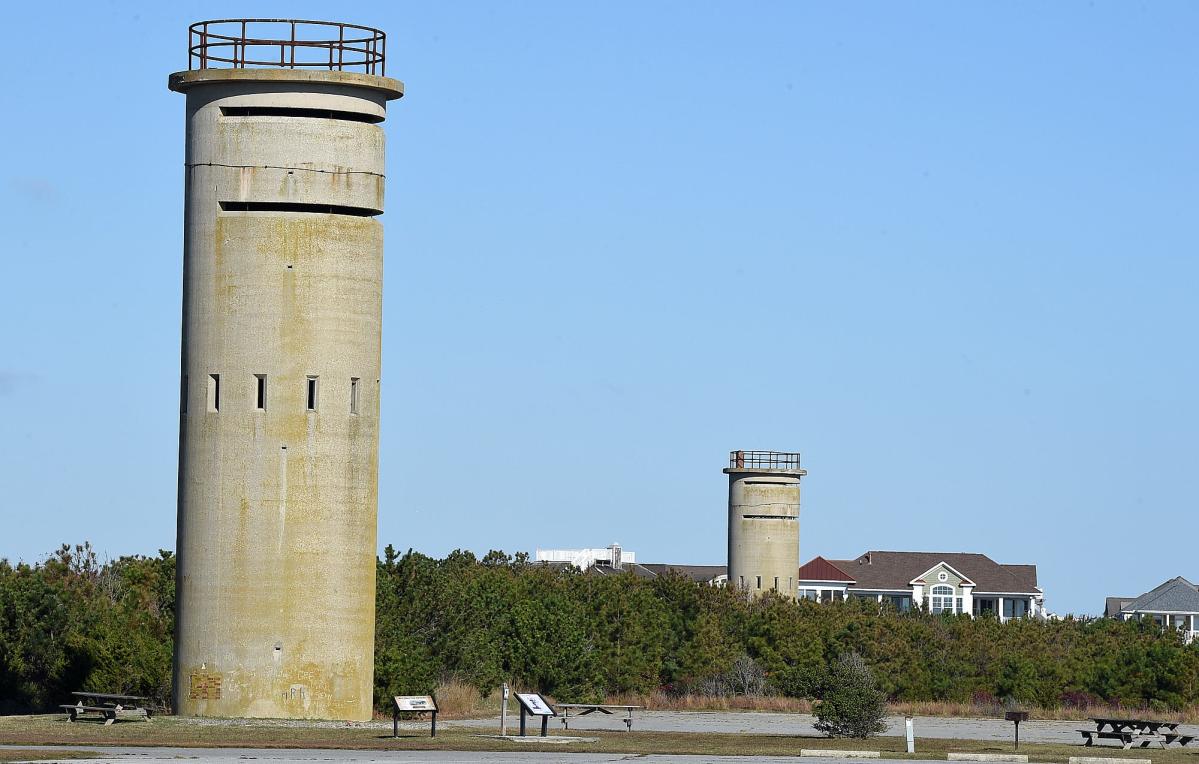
[169,19,403,720]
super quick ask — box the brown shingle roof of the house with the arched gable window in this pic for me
[830,551,1038,594]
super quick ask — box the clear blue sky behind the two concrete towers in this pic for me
[0,1,1199,613]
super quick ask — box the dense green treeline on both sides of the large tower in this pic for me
[0,545,1199,712]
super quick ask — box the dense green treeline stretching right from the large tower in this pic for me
[375,548,1199,709]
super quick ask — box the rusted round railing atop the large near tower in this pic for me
[187,18,387,77]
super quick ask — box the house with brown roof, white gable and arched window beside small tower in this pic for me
[799,551,1044,621]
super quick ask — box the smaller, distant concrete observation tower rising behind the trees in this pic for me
[724,451,807,598]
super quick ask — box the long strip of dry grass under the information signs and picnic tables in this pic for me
[7,715,1199,764]
